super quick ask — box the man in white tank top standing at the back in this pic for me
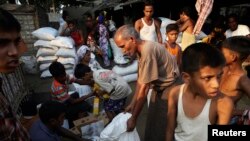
[135,2,162,43]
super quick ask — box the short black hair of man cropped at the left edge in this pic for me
[0,8,21,33]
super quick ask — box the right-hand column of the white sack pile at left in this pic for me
[50,36,76,75]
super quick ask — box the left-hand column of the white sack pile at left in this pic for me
[32,27,58,78]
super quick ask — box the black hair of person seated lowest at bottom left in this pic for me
[39,100,66,124]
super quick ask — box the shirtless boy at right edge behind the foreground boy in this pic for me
[220,36,250,121]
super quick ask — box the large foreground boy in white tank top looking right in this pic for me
[166,43,233,141]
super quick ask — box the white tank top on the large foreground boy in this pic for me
[175,84,211,141]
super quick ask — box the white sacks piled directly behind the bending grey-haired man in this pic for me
[109,38,138,82]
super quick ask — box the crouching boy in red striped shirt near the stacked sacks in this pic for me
[49,62,93,127]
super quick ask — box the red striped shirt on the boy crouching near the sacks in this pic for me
[51,80,70,102]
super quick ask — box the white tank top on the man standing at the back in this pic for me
[140,18,158,42]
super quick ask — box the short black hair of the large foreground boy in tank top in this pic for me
[182,43,226,74]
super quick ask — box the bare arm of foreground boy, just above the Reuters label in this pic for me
[217,96,234,125]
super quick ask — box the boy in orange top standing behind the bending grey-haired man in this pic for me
[165,24,182,69]
